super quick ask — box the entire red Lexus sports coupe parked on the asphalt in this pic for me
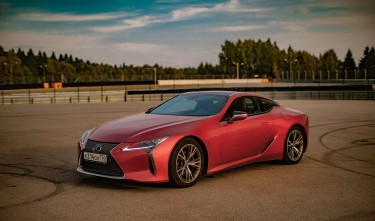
[77,91,309,187]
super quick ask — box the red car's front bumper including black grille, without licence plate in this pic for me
[77,138,178,182]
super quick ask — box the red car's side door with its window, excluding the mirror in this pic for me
[220,97,272,162]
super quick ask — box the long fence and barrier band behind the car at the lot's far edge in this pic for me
[0,80,375,105]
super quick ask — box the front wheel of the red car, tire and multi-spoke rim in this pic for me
[169,138,205,188]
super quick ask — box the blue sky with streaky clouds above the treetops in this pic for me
[0,0,375,68]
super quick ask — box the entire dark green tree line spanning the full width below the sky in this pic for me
[0,39,375,84]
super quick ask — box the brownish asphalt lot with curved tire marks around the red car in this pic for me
[0,100,375,220]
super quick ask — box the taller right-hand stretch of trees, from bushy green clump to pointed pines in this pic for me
[219,39,375,79]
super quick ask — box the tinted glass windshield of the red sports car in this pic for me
[150,94,228,116]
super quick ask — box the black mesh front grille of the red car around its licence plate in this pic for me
[81,140,124,177]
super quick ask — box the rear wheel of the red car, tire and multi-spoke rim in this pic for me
[282,126,306,164]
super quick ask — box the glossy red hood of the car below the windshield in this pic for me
[88,113,207,143]
